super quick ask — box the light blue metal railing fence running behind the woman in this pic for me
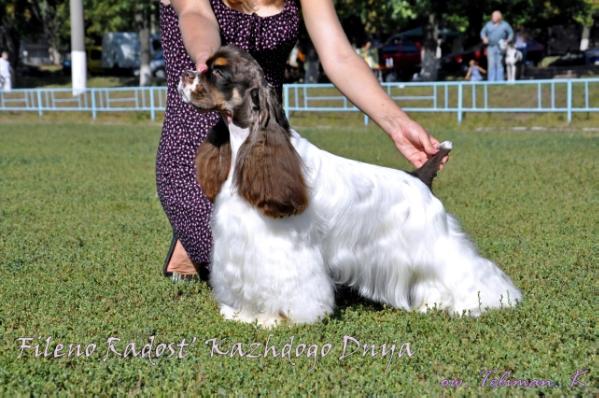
[0,78,599,124]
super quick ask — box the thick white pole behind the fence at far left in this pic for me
[70,0,87,96]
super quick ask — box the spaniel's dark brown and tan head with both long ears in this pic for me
[184,47,308,217]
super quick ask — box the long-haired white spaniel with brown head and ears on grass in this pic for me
[179,47,522,326]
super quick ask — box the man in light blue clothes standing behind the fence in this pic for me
[480,11,514,81]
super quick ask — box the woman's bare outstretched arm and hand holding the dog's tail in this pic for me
[301,0,446,167]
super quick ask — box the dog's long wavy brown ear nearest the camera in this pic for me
[235,83,308,218]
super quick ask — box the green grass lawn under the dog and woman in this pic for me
[0,118,599,397]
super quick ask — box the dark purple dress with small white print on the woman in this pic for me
[156,0,300,265]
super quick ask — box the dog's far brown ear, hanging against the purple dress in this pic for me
[196,119,231,202]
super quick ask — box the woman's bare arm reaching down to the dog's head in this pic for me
[171,0,220,71]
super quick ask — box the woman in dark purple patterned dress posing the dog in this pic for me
[156,0,448,279]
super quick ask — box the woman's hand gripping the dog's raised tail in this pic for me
[389,119,448,169]
